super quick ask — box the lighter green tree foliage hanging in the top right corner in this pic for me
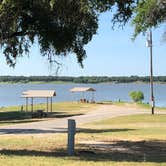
[132,0,166,38]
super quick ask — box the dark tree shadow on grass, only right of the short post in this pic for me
[78,141,166,163]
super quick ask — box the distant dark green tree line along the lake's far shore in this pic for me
[0,76,166,84]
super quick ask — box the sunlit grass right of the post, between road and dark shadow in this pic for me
[83,114,166,141]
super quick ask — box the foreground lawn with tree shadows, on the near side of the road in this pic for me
[0,115,166,166]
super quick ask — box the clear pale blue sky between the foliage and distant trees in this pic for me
[0,13,166,77]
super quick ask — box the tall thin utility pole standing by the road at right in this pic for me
[149,30,155,115]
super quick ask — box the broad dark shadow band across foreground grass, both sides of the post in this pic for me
[0,141,166,163]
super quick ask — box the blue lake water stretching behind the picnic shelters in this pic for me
[0,83,166,107]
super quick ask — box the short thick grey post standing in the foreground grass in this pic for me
[68,119,76,156]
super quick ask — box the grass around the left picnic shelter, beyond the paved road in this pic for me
[0,102,97,125]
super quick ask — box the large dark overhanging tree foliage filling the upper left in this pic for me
[0,0,137,66]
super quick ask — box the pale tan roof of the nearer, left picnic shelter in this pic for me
[22,90,56,98]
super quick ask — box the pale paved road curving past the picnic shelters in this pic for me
[0,105,164,135]
